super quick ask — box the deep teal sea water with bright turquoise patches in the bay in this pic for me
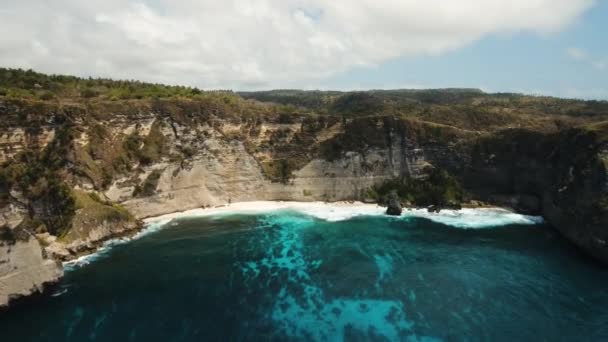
[0,211,608,341]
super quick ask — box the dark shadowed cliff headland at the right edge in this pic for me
[466,129,608,263]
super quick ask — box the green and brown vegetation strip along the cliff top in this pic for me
[0,68,608,135]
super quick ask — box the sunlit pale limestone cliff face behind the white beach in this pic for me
[104,114,466,218]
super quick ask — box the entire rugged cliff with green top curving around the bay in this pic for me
[0,71,608,308]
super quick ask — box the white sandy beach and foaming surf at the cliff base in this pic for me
[62,201,544,271]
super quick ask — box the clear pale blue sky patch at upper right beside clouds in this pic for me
[323,1,608,99]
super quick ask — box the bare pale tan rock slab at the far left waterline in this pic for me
[0,231,63,309]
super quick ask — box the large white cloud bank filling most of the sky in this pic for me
[0,0,594,89]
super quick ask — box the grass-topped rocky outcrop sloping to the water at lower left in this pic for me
[0,191,141,309]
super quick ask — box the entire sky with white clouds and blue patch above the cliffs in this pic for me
[0,0,608,100]
